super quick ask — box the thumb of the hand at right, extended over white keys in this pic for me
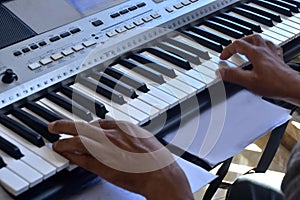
[217,68,251,87]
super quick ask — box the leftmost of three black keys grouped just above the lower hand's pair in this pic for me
[79,77,126,105]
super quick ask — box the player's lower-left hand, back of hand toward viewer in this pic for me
[48,120,193,200]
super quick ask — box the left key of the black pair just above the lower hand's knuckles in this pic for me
[46,92,93,121]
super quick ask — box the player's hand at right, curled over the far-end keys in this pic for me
[219,34,300,99]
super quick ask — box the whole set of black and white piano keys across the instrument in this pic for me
[0,0,300,196]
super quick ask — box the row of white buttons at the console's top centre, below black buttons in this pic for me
[106,13,161,37]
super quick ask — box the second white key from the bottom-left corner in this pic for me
[0,151,43,187]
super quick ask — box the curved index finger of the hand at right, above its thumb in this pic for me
[220,39,256,61]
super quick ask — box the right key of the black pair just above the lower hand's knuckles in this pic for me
[60,86,108,119]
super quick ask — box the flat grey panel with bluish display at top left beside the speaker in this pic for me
[3,0,127,34]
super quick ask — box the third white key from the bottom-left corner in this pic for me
[0,129,56,179]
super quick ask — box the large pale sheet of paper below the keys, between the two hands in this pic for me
[164,90,291,166]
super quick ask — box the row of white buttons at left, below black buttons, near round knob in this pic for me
[28,40,96,70]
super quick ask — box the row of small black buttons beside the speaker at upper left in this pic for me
[13,28,81,56]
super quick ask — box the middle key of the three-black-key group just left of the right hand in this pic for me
[157,42,201,65]
